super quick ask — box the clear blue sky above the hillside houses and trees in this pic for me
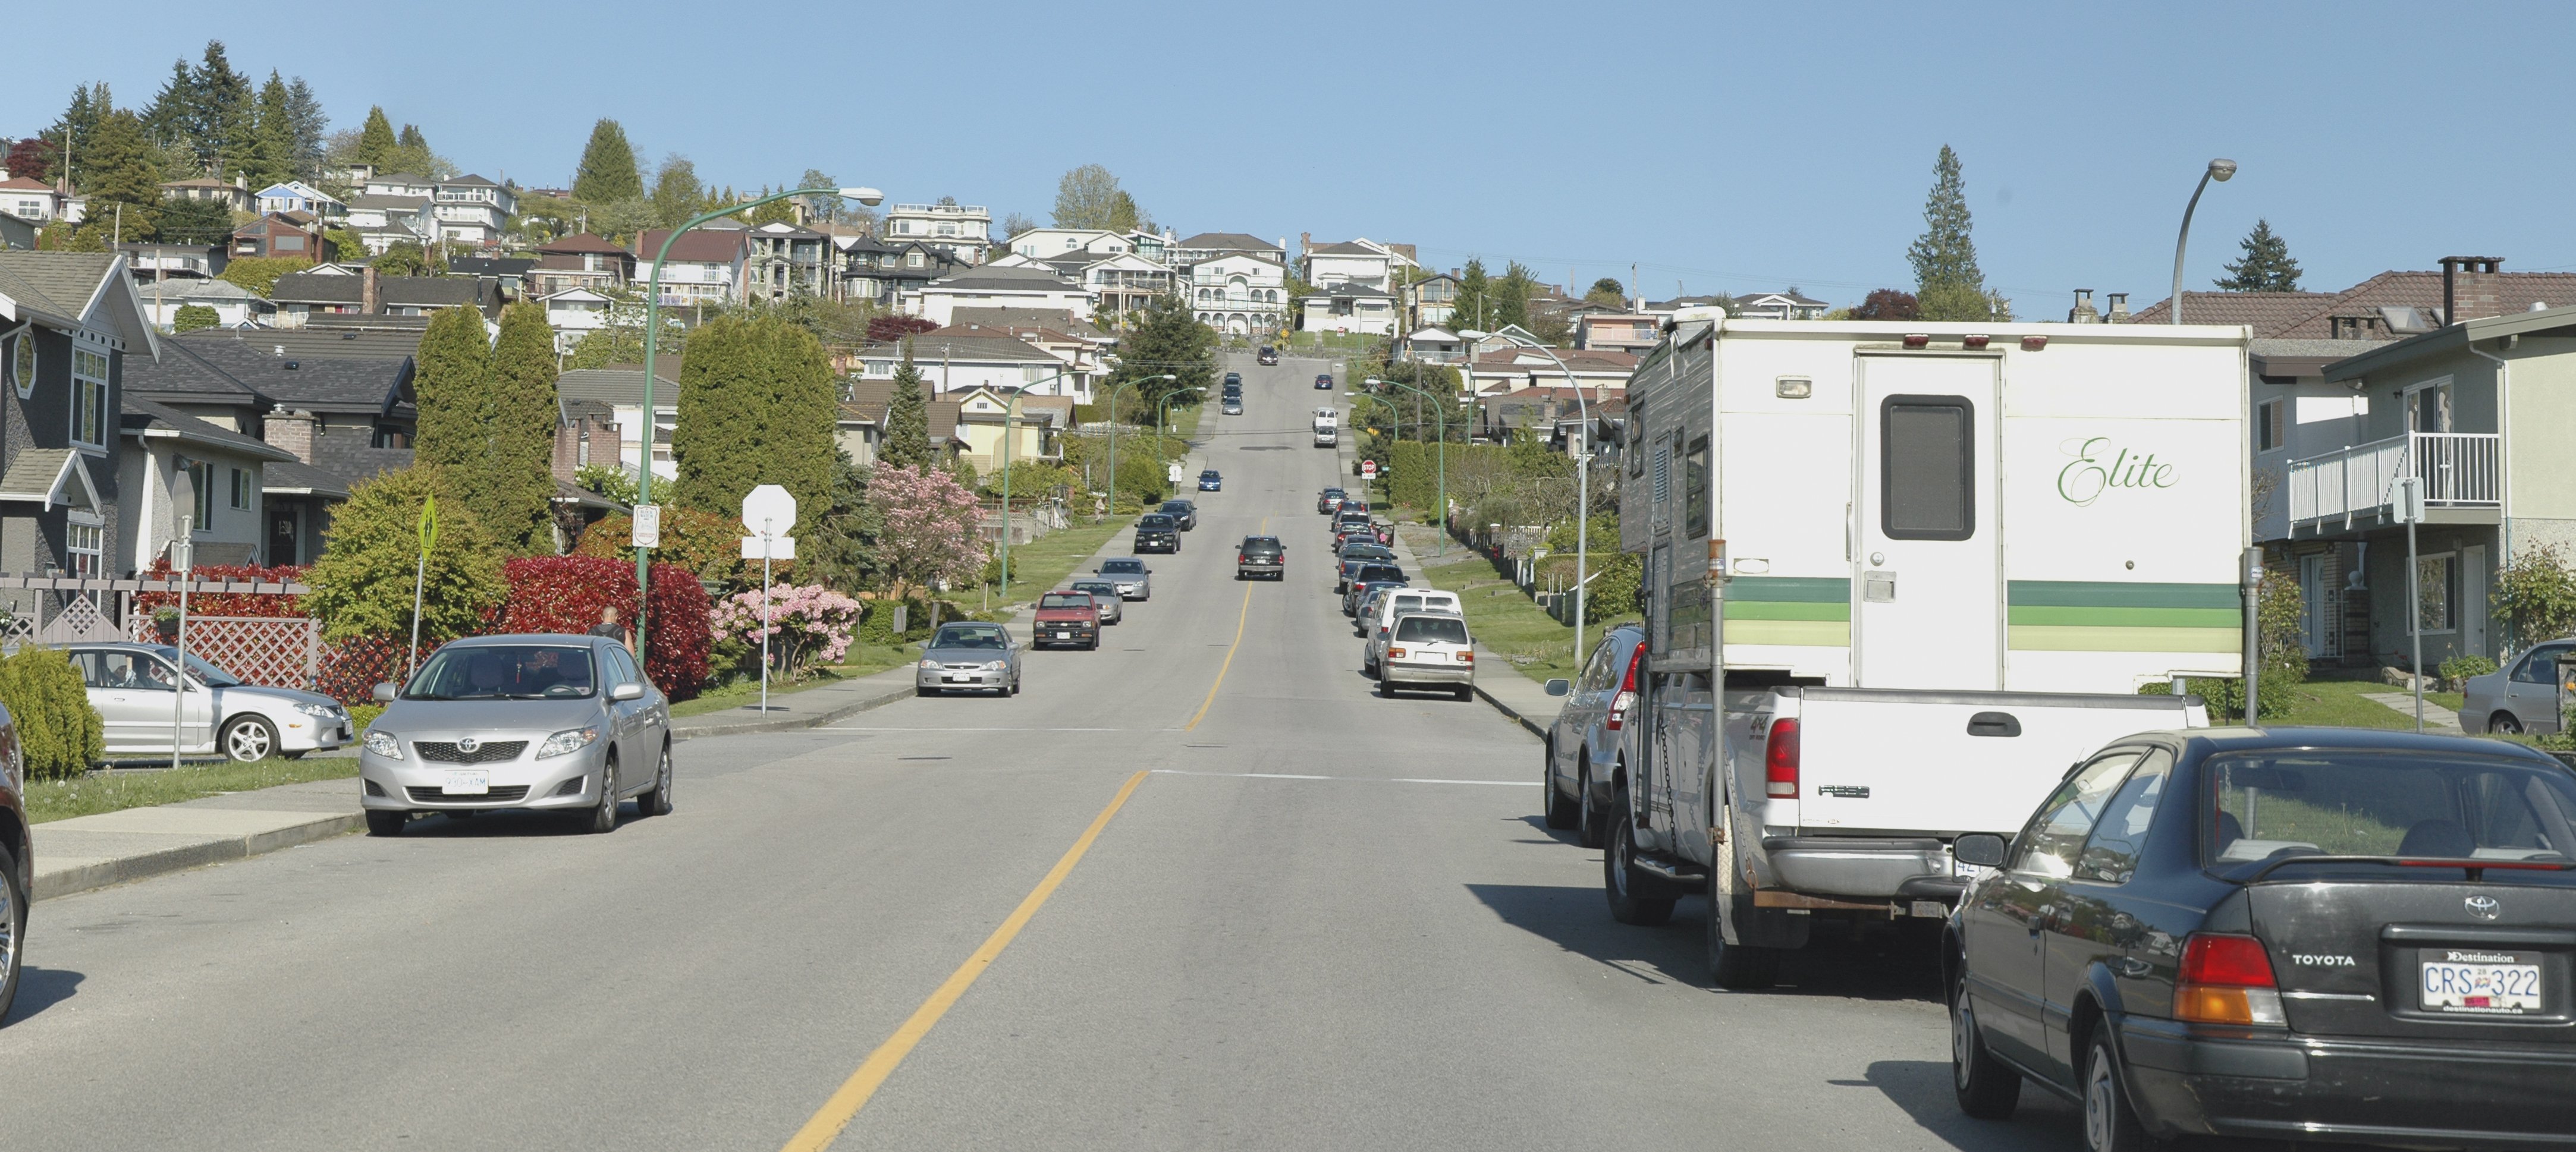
[0,0,2576,317]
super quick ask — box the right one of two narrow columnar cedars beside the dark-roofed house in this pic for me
[484,301,559,556]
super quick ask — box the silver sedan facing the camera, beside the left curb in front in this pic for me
[358,634,670,835]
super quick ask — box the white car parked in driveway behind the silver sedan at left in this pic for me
[64,642,356,760]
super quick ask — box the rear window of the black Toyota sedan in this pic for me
[2200,750,2576,866]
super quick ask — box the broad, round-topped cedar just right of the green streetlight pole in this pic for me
[670,317,835,536]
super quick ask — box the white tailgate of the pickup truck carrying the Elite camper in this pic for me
[1798,688,2208,835]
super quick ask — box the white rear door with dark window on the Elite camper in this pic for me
[1852,355,2004,688]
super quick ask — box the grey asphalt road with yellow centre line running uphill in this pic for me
[0,358,2079,1150]
